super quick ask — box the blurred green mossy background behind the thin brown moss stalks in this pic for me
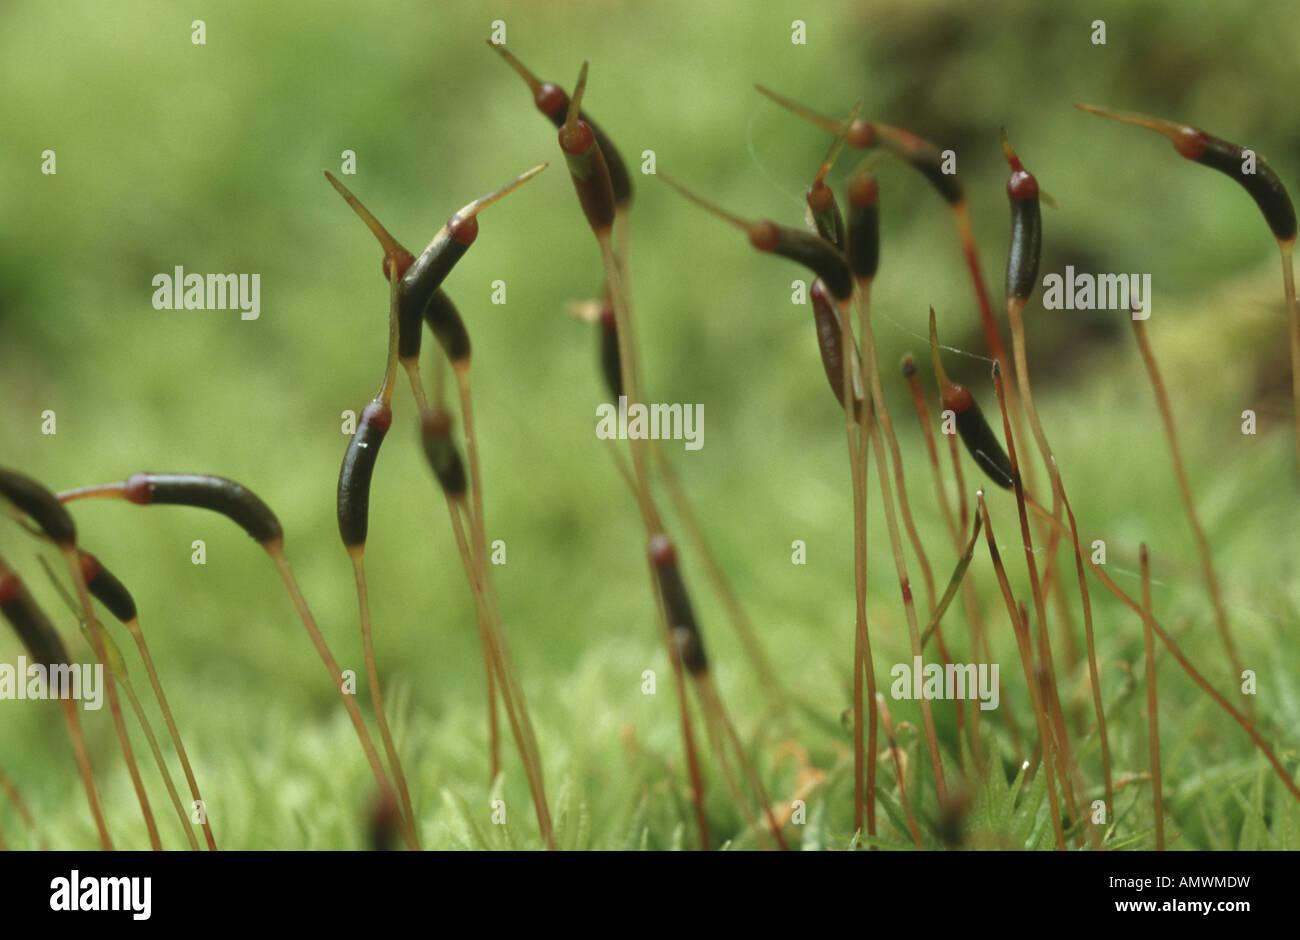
[0,0,1300,848]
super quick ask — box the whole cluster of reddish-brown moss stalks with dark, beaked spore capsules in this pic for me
[0,43,1300,850]
